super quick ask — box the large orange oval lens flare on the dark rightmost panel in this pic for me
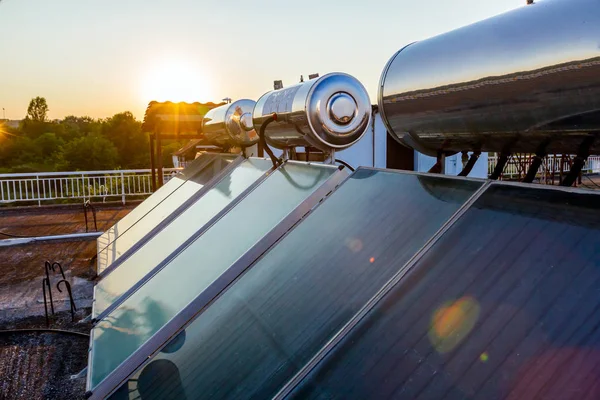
[429,296,480,353]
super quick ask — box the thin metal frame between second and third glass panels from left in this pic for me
[92,159,279,326]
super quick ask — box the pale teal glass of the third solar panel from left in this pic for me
[90,163,337,390]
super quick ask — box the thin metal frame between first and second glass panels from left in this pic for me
[96,157,245,279]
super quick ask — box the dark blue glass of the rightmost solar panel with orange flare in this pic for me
[292,185,600,399]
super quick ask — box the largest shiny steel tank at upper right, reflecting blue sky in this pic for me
[378,0,600,155]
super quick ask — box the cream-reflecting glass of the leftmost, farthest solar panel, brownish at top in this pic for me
[98,155,233,273]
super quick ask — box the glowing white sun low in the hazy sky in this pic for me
[141,61,211,103]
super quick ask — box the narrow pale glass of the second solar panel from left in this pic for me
[94,159,272,315]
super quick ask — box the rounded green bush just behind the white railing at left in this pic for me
[63,134,119,171]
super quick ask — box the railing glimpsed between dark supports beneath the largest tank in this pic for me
[488,155,600,178]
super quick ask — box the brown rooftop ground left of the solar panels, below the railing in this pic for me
[0,204,136,400]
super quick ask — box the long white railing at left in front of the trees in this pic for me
[0,168,181,205]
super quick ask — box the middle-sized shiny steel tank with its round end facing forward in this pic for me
[253,73,371,152]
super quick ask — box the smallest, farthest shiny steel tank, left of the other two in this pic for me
[202,99,258,147]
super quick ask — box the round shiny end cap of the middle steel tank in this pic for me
[306,73,371,149]
